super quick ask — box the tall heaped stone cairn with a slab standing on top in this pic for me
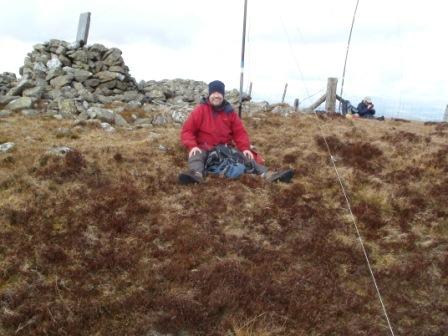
[7,40,137,102]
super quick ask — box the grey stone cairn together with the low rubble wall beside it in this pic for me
[0,40,288,127]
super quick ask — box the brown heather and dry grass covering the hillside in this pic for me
[0,114,448,336]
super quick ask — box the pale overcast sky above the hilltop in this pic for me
[0,0,448,119]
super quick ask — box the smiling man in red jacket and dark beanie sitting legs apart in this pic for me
[179,80,294,184]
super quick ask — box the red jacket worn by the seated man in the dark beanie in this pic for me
[181,101,250,151]
